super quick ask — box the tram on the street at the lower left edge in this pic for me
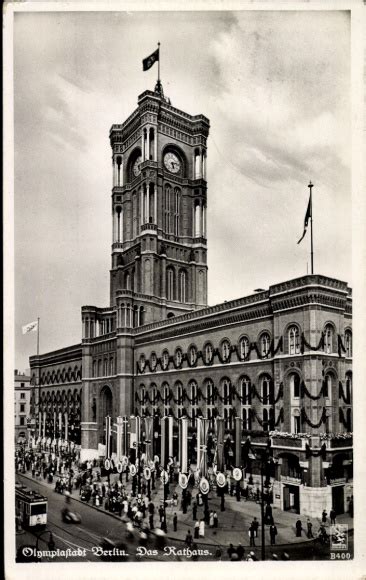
[15,483,48,528]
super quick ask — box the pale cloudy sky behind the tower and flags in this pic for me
[14,10,352,370]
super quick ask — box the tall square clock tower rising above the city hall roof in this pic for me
[110,81,209,326]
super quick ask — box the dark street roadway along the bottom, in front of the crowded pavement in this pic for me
[17,473,353,562]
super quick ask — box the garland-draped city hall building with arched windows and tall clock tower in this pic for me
[30,82,353,515]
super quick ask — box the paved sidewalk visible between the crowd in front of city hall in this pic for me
[20,472,353,548]
